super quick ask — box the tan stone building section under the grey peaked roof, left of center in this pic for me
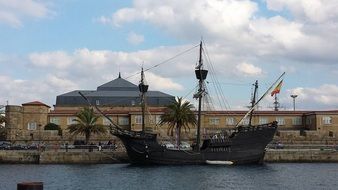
[6,75,175,141]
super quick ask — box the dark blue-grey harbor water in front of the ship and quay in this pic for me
[0,163,338,190]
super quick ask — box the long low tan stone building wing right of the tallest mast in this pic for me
[202,110,338,141]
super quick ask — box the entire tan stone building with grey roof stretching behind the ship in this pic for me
[6,76,338,141]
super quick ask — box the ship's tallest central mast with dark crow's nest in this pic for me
[194,41,208,151]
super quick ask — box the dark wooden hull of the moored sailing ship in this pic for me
[115,123,277,164]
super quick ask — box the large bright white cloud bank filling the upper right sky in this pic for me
[99,0,338,64]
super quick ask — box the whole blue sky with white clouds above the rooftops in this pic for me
[0,0,338,110]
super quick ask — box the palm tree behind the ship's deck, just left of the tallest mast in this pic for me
[160,97,197,148]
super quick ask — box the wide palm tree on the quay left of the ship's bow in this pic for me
[68,107,107,144]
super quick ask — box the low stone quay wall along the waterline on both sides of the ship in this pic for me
[0,149,338,164]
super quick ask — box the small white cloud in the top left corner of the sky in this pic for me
[0,0,52,28]
